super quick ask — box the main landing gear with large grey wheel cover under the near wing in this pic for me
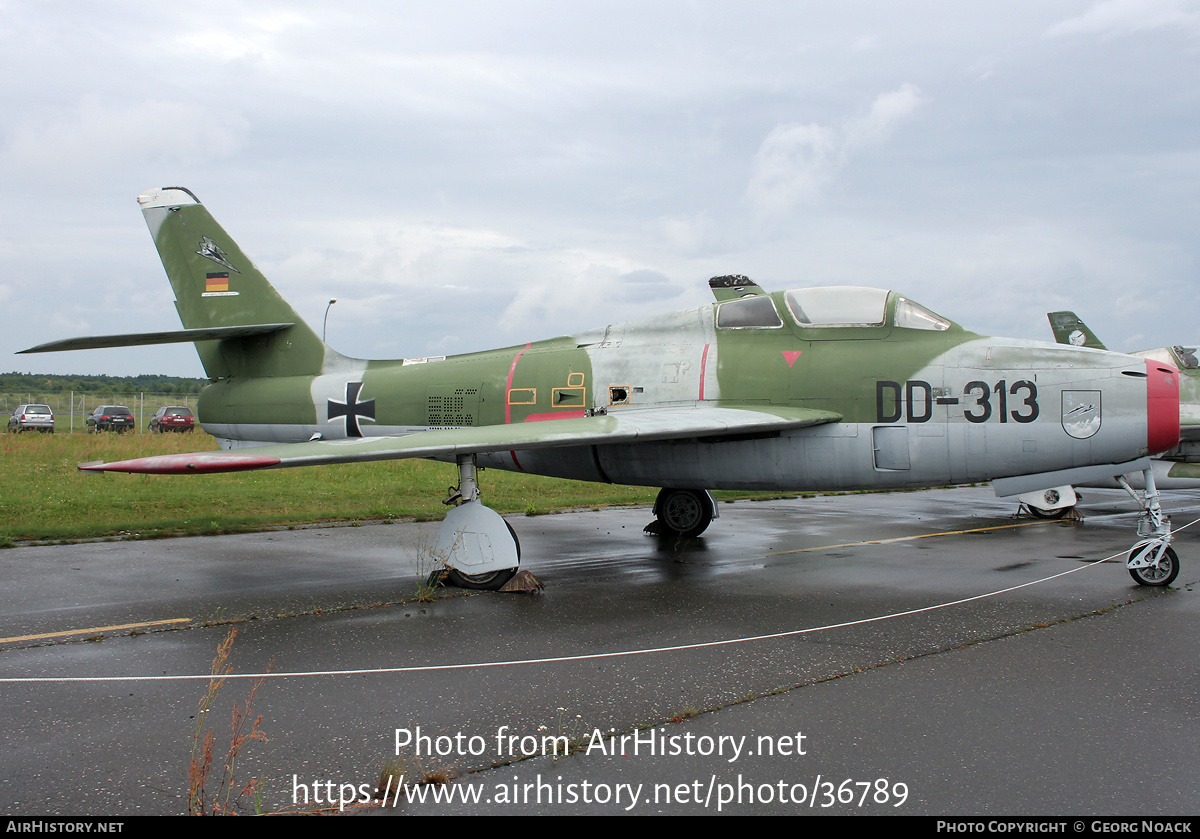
[432,455,521,592]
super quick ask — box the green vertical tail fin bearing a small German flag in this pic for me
[138,186,336,378]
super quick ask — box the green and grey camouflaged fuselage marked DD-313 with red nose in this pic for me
[198,292,1174,490]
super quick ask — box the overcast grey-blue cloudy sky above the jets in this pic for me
[0,0,1200,376]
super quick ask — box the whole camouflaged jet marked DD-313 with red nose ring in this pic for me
[16,187,1180,588]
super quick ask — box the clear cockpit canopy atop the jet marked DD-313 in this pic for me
[716,286,952,331]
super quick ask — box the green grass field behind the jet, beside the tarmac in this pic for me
[0,431,764,546]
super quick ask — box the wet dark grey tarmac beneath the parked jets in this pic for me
[0,487,1200,817]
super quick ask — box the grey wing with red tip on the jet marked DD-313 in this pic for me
[79,406,841,474]
